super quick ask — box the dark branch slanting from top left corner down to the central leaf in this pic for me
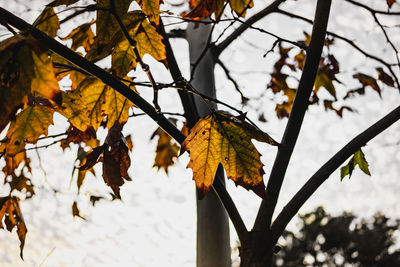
[0,7,186,143]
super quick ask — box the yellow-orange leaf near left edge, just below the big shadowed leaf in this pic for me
[6,106,54,155]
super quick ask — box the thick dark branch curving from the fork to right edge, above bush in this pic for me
[271,106,400,245]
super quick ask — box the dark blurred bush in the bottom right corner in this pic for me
[273,207,400,267]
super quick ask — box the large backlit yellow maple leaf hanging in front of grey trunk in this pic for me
[182,112,277,197]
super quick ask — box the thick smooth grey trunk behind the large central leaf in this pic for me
[187,23,231,267]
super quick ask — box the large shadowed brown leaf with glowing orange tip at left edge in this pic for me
[0,35,60,131]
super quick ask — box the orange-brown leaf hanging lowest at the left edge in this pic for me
[0,197,28,259]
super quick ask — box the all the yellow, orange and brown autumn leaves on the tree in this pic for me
[0,0,396,262]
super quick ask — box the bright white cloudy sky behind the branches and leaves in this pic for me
[0,0,400,267]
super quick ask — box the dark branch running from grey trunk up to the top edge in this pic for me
[214,0,286,56]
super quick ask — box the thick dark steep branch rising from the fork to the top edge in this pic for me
[254,0,331,231]
